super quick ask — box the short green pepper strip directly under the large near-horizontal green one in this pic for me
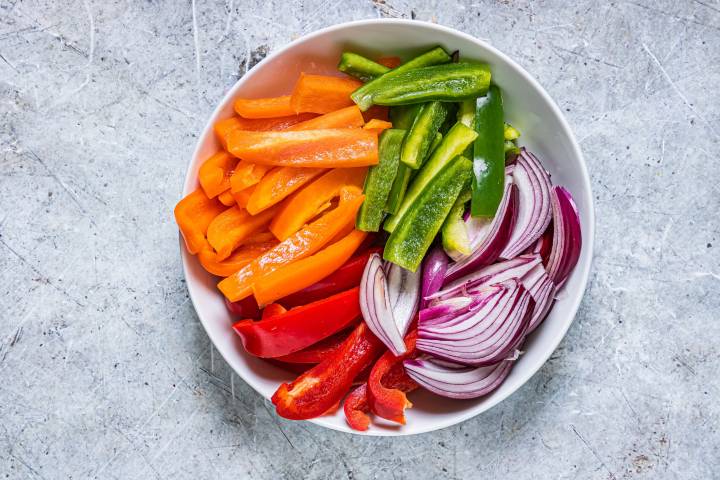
[400,102,448,169]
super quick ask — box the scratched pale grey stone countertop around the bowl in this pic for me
[0,0,720,480]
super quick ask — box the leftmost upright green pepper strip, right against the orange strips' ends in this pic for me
[357,128,405,232]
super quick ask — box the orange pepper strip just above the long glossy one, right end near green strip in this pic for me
[269,168,367,240]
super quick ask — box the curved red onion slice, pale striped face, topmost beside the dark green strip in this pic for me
[500,148,552,259]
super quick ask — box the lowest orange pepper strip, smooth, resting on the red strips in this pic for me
[252,230,367,305]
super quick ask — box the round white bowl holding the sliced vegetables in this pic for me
[180,20,595,435]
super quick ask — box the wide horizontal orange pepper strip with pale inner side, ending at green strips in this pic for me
[228,128,378,168]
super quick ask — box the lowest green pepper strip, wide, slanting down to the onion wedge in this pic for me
[383,156,472,272]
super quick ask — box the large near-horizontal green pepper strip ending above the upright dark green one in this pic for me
[352,63,490,110]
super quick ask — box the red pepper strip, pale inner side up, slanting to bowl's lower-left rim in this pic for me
[272,323,383,420]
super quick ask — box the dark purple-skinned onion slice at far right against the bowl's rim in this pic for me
[547,186,582,289]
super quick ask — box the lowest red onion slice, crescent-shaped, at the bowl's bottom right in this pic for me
[403,356,513,399]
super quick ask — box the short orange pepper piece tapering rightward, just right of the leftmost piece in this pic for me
[207,205,275,260]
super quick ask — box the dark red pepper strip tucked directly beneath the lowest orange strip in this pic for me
[278,247,382,308]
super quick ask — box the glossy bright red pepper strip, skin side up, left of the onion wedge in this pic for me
[233,287,360,358]
